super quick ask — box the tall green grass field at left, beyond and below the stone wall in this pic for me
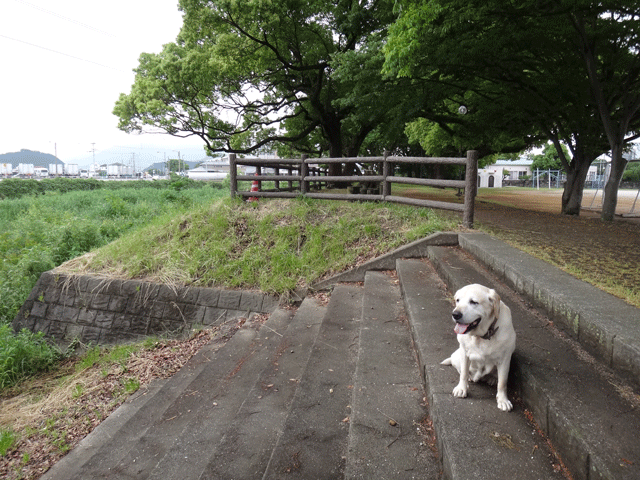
[0,179,229,390]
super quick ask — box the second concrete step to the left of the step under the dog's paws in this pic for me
[262,285,363,480]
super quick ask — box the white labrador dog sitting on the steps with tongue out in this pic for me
[442,284,516,412]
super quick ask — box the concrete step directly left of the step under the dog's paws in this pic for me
[345,272,440,480]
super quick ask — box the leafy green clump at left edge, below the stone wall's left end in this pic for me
[0,324,62,389]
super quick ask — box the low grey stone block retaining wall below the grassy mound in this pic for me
[13,271,279,344]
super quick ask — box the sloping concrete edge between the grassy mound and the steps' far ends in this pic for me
[311,232,459,290]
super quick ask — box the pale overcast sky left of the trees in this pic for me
[0,0,204,165]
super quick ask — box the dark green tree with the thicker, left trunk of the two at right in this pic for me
[386,0,633,218]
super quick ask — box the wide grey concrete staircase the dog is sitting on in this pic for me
[42,234,640,480]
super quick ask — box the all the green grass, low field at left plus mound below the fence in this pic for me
[0,184,457,395]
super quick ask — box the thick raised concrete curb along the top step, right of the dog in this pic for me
[458,232,640,385]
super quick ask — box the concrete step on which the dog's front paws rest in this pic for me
[397,260,564,480]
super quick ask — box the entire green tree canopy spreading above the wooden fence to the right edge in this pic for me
[114,0,640,220]
